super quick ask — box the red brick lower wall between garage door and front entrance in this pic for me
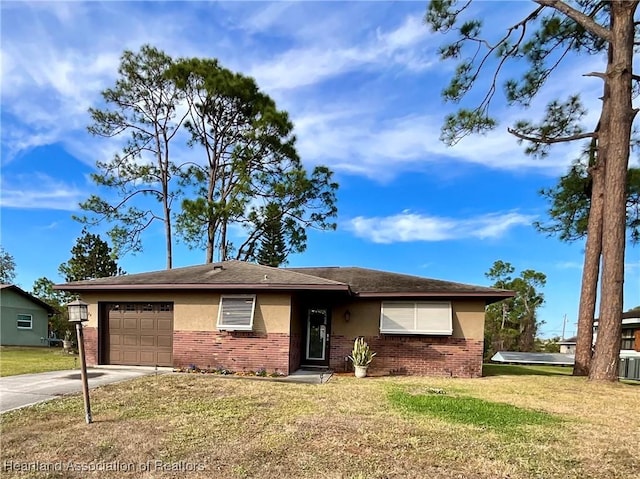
[173,331,290,374]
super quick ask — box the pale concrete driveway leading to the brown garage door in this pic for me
[0,366,171,413]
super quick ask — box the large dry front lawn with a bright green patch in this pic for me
[0,374,640,479]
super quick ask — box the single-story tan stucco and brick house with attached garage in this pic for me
[55,261,514,377]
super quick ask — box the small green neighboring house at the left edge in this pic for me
[0,284,56,346]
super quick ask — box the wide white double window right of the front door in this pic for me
[380,301,453,335]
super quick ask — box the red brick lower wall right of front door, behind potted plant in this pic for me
[330,335,483,377]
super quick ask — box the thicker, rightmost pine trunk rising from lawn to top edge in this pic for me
[589,1,637,381]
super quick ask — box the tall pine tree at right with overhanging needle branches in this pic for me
[425,0,640,381]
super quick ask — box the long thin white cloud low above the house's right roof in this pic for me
[346,211,535,244]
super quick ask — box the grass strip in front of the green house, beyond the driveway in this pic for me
[0,346,77,376]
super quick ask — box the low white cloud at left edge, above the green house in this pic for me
[0,173,88,211]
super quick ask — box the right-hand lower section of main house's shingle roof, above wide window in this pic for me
[289,267,513,298]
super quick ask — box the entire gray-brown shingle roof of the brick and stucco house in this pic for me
[56,261,513,302]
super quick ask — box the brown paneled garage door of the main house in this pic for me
[105,303,173,366]
